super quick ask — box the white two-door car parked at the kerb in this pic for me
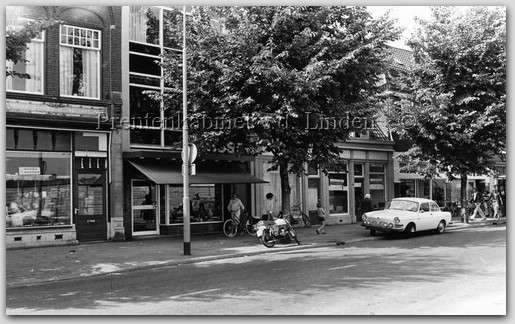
[361,197,451,236]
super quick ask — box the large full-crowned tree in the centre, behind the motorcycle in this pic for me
[165,6,399,212]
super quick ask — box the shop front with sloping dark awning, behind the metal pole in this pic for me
[124,153,266,239]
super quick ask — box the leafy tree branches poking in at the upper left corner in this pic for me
[5,7,60,79]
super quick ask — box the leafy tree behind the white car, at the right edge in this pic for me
[390,7,506,219]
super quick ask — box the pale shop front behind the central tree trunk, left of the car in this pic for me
[255,140,394,224]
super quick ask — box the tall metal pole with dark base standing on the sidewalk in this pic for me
[182,6,191,255]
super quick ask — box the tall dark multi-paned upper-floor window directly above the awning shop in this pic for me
[129,6,183,148]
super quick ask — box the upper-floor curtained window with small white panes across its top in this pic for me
[59,25,101,99]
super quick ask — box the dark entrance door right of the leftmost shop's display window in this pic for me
[74,170,107,242]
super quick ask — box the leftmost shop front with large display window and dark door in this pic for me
[5,127,108,247]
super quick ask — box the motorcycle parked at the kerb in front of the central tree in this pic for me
[256,215,300,248]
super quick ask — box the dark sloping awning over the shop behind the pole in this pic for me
[129,160,267,184]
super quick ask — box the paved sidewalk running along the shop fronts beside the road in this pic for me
[6,219,506,286]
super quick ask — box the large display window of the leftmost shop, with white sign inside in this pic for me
[6,151,71,228]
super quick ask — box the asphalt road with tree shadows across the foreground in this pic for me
[6,226,506,315]
